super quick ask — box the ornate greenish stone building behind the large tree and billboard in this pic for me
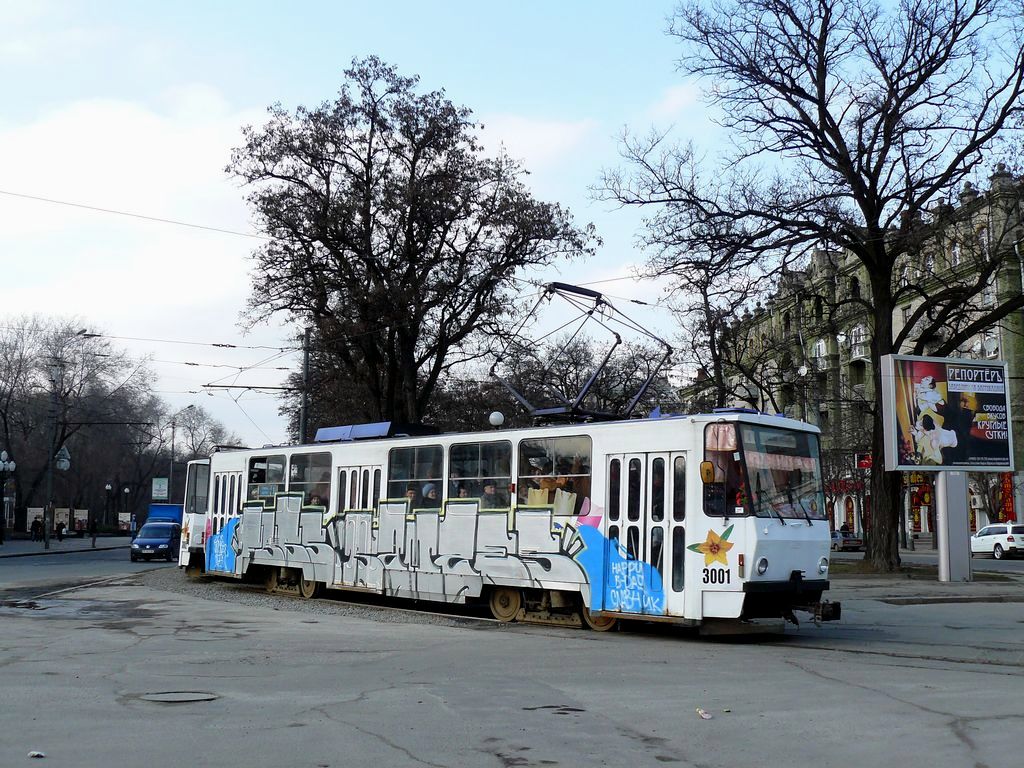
[689,164,1024,540]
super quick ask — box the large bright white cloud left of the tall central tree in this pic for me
[0,84,295,444]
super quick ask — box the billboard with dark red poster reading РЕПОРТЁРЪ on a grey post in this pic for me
[882,354,1014,472]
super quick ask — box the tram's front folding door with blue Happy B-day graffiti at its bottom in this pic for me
[604,453,686,615]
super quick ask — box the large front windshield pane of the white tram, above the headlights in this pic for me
[739,424,825,520]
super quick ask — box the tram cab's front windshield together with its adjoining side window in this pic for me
[703,423,825,520]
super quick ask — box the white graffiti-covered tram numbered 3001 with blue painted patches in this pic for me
[179,410,839,629]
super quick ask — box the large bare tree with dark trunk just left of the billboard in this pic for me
[604,0,1024,569]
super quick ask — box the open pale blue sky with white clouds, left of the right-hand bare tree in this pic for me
[0,0,715,445]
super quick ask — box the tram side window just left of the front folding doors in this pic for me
[517,435,592,515]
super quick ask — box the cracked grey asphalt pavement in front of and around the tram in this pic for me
[0,553,1024,768]
